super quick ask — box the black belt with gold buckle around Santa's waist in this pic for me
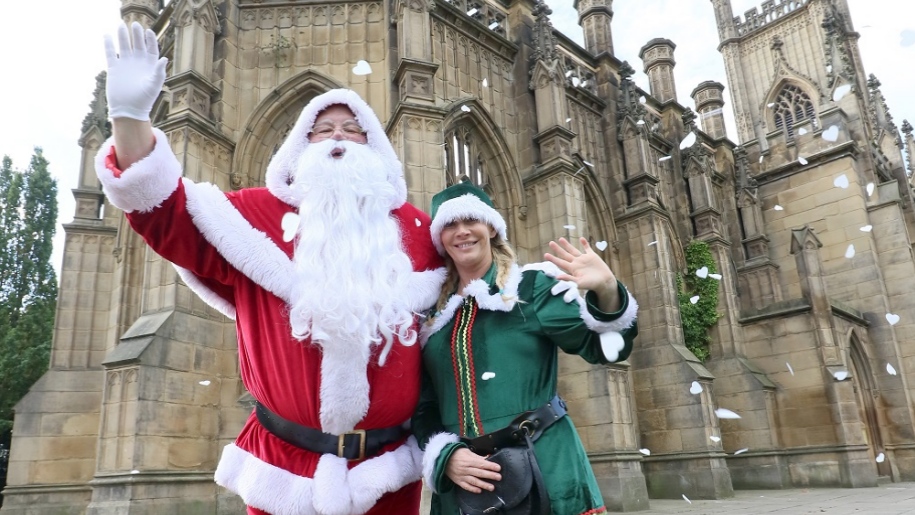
[254,402,404,460]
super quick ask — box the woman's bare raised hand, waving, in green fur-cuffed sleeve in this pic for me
[543,238,620,313]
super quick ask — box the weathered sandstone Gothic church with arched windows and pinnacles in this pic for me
[0,0,915,515]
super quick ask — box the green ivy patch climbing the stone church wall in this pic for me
[677,240,720,363]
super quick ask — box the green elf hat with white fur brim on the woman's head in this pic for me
[429,182,508,256]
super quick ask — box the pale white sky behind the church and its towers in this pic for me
[0,0,915,278]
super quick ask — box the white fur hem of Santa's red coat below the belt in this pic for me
[215,436,421,515]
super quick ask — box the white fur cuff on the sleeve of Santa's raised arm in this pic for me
[95,128,181,213]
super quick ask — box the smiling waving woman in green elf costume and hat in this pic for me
[413,182,638,515]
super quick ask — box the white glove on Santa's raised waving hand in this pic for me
[105,22,168,121]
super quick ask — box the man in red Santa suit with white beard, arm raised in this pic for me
[96,23,443,515]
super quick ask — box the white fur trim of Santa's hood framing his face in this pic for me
[266,89,407,209]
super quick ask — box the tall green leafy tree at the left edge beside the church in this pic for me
[0,148,57,437]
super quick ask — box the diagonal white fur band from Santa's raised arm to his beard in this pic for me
[184,180,295,307]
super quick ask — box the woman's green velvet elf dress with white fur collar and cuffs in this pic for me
[412,263,638,515]
